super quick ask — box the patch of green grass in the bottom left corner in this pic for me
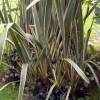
[0,64,18,100]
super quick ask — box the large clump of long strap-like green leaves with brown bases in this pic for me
[0,0,99,100]
